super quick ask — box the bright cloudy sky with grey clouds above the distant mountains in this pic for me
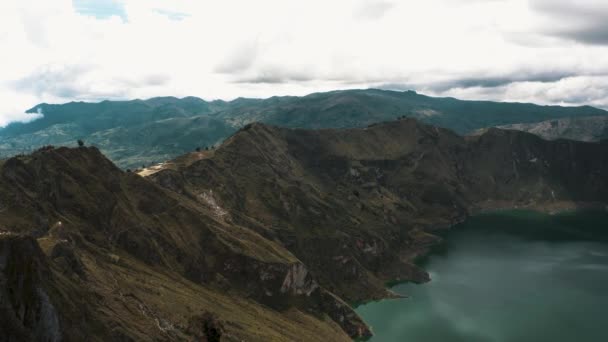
[0,0,608,126]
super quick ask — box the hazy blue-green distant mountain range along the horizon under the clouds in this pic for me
[0,89,608,168]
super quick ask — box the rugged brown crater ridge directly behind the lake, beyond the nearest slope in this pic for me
[150,119,608,302]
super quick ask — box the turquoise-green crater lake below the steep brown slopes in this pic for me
[357,211,608,342]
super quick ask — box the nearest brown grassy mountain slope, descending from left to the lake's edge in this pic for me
[0,147,360,341]
